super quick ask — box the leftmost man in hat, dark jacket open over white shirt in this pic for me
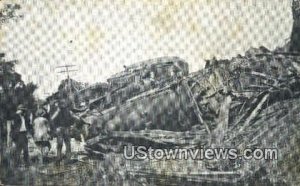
[10,104,33,166]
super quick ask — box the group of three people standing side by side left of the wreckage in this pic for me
[10,100,80,166]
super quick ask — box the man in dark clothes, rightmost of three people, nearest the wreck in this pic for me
[51,100,80,161]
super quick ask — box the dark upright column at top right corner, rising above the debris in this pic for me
[289,0,300,52]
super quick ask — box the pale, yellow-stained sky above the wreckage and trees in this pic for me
[0,0,293,98]
